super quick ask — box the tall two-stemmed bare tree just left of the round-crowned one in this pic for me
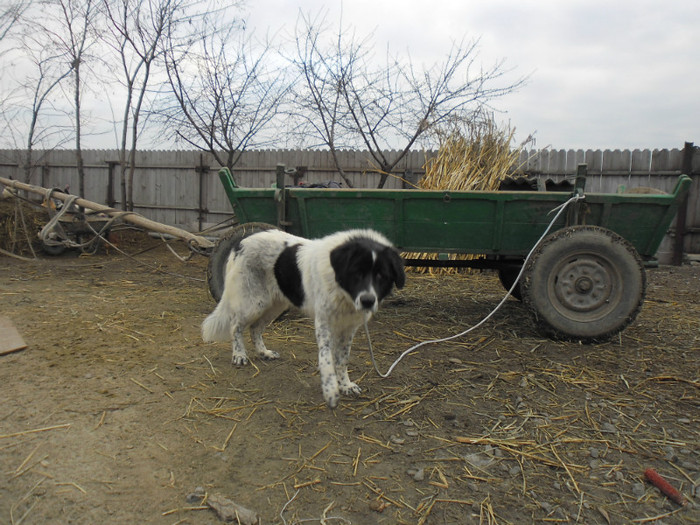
[102,0,185,210]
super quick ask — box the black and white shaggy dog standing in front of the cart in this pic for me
[202,230,406,408]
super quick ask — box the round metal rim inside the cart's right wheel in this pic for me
[548,254,621,321]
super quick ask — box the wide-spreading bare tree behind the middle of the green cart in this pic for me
[292,16,523,188]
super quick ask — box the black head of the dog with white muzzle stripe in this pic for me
[331,237,406,312]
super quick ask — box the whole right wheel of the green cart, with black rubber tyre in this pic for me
[521,226,646,343]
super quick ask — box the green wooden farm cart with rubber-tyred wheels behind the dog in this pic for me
[208,165,691,342]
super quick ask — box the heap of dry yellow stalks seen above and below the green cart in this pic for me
[404,119,522,273]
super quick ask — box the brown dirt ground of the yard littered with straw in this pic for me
[0,231,700,524]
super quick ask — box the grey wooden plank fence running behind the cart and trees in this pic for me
[0,144,700,262]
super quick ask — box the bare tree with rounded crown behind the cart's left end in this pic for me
[161,18,289,175]
